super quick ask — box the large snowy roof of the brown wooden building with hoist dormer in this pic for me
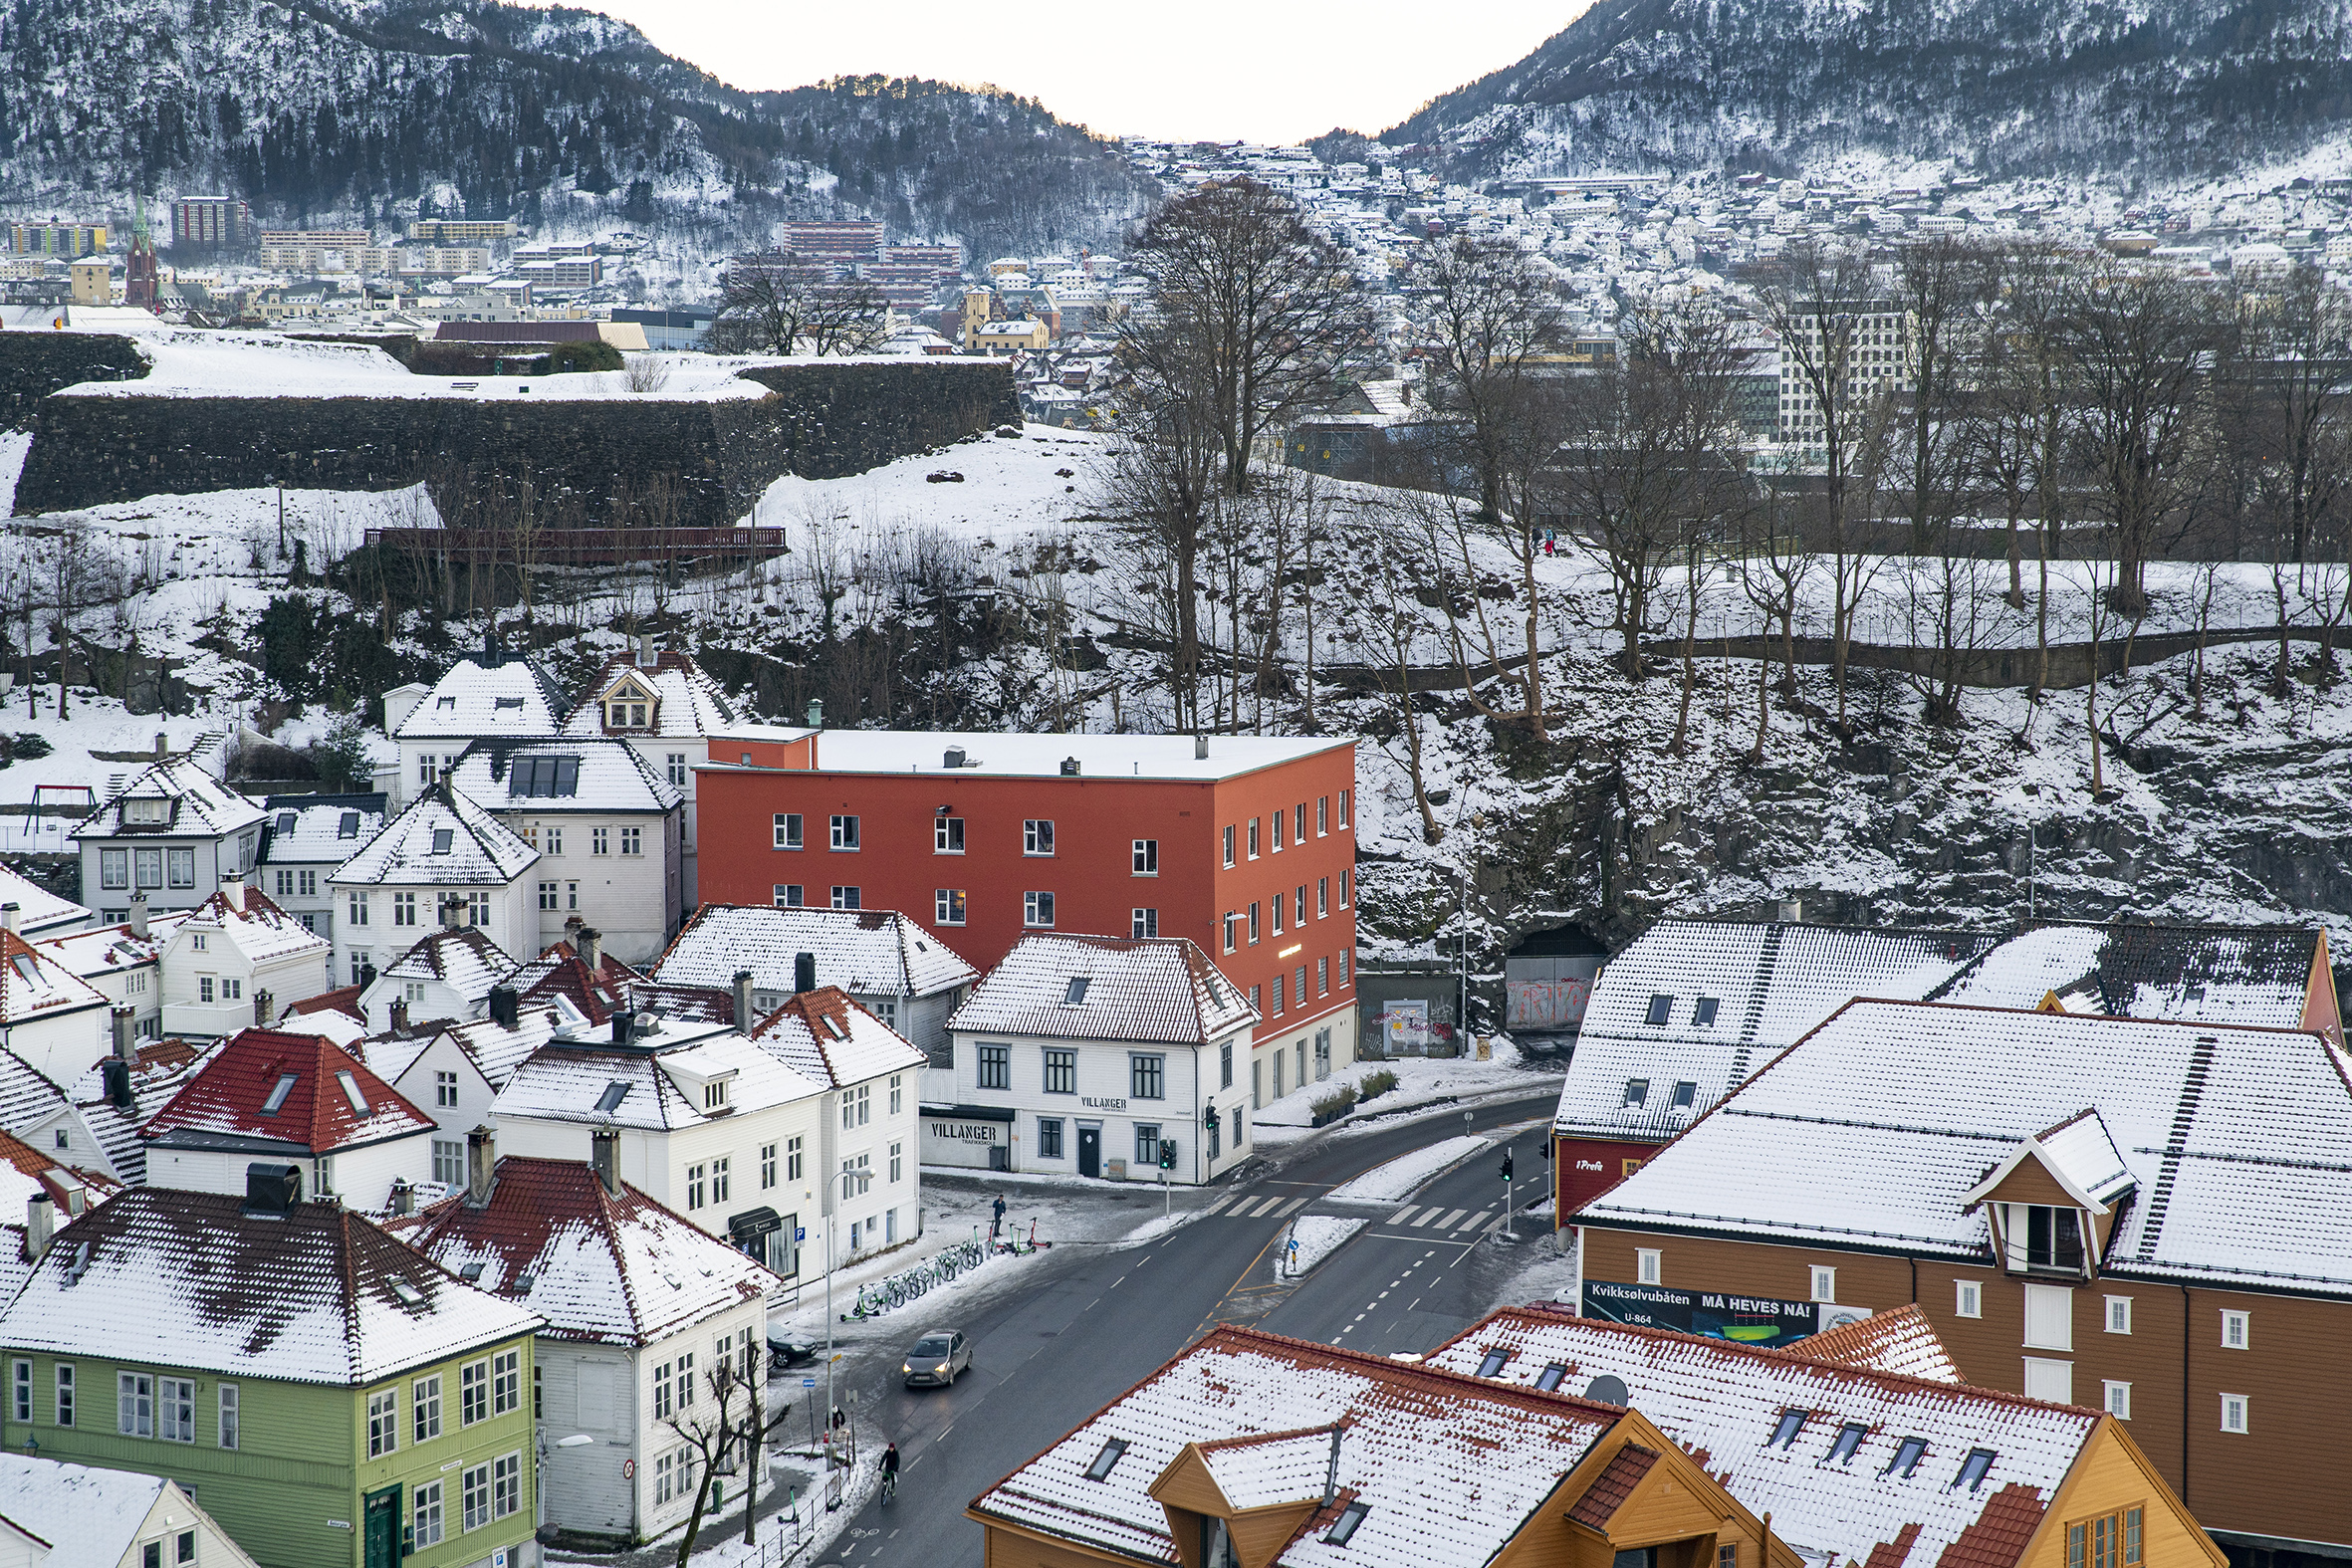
[1578,1002,2352,1295]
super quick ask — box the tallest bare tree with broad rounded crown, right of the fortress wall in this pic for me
[1119,178,1371,494]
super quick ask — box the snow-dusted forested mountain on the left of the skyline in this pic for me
[0,0,1141,256]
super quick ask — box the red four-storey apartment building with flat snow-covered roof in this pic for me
[696,729,1355,1086]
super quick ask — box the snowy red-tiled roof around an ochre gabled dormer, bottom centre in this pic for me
[972,1326,1623,1568]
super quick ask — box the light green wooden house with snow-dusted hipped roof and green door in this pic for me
[0,1185,541,1568]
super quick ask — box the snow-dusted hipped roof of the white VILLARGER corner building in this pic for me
[948,936,1259,1046]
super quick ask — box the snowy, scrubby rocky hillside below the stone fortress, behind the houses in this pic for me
[0,425,2352,983]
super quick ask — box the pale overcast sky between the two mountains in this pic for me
[557,0,1590,143]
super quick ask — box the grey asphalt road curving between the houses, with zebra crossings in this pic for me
[821,1091,1554,1568]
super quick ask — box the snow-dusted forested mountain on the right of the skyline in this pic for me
[1380,0,2352,181]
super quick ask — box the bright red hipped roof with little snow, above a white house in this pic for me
[138,1027,433,1154]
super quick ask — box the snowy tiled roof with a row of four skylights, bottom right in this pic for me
[1428,1309,2100,1568]
